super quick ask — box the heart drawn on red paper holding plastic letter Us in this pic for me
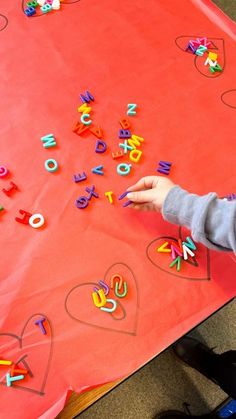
[65,262,139,335]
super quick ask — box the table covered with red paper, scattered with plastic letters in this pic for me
[0,0,236,419]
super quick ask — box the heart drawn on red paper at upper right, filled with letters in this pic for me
[175,35,225,79]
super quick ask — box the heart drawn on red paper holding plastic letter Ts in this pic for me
[0,314,52,396]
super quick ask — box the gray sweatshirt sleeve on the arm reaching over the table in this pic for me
[162,186,236,252]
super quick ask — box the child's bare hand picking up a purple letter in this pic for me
[127,176,175,211]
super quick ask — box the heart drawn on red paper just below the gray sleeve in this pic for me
[146,227,211,281]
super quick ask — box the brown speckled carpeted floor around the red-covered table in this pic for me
[78,0,236,419]
